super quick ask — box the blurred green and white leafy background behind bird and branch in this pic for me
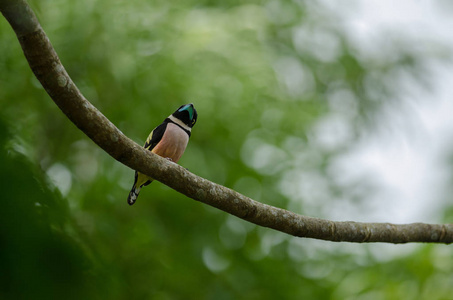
[0,0,453,299]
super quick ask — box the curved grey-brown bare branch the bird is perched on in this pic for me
[0,0,453,244]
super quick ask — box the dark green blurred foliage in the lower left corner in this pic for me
[0,122,104,299]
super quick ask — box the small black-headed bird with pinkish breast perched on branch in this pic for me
[127,103,198,205]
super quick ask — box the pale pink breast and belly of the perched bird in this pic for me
[152,123,189,162]
